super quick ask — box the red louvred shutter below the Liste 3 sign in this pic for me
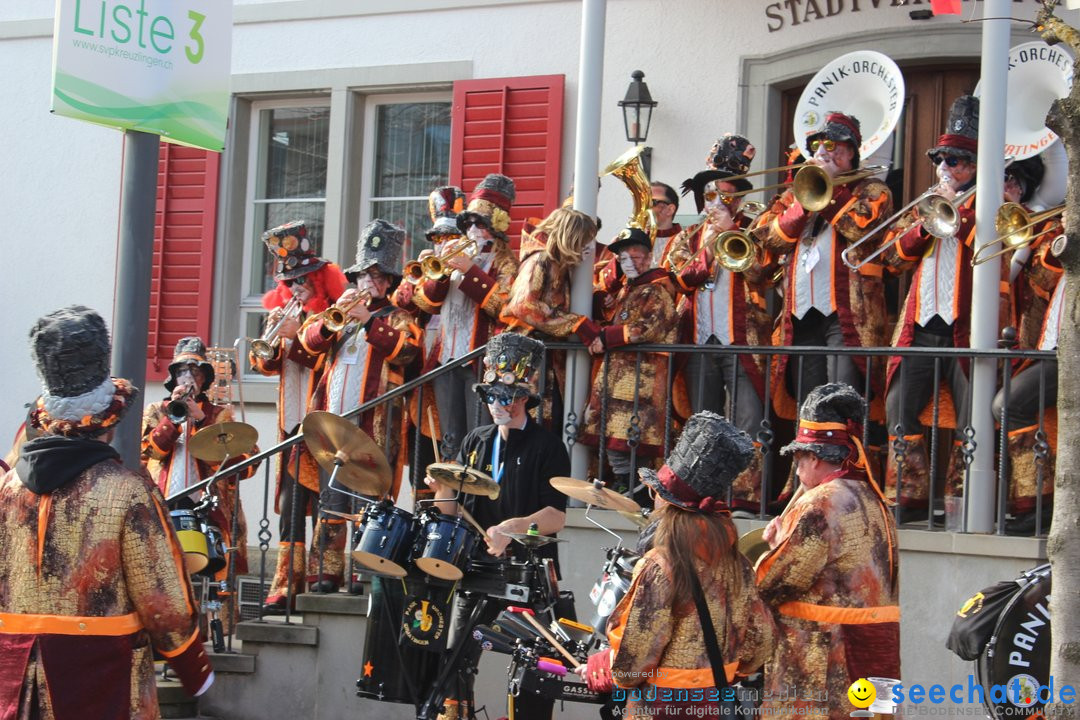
[146,142,221,383]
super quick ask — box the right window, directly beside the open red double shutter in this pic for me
[360,95,450,260]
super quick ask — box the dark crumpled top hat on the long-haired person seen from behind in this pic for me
[637,410,755,513]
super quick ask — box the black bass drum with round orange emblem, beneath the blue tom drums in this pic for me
[356,575,438,707]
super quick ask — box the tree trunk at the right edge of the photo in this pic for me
[1039,1,1080,719]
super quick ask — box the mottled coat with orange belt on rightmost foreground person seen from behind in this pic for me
[757,478,901,720]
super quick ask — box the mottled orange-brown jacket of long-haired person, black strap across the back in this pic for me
[607,520,777,717]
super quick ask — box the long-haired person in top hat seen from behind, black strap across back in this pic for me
[577,411,777,718]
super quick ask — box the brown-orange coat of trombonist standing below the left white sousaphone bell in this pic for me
[753,178,892,418]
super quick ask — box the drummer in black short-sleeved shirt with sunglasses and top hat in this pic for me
[424,332,570,720]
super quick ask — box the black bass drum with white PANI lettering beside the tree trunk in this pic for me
[975,565,1056,718]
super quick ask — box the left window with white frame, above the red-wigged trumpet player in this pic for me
[241,98,330,362]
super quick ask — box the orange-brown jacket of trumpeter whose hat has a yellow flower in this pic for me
[413,241,517,364]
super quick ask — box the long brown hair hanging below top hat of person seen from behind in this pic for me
[653,504,734,613]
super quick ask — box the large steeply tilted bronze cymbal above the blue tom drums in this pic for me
[300,411,392,497]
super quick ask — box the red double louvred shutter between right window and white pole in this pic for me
[450,74,566,247]
